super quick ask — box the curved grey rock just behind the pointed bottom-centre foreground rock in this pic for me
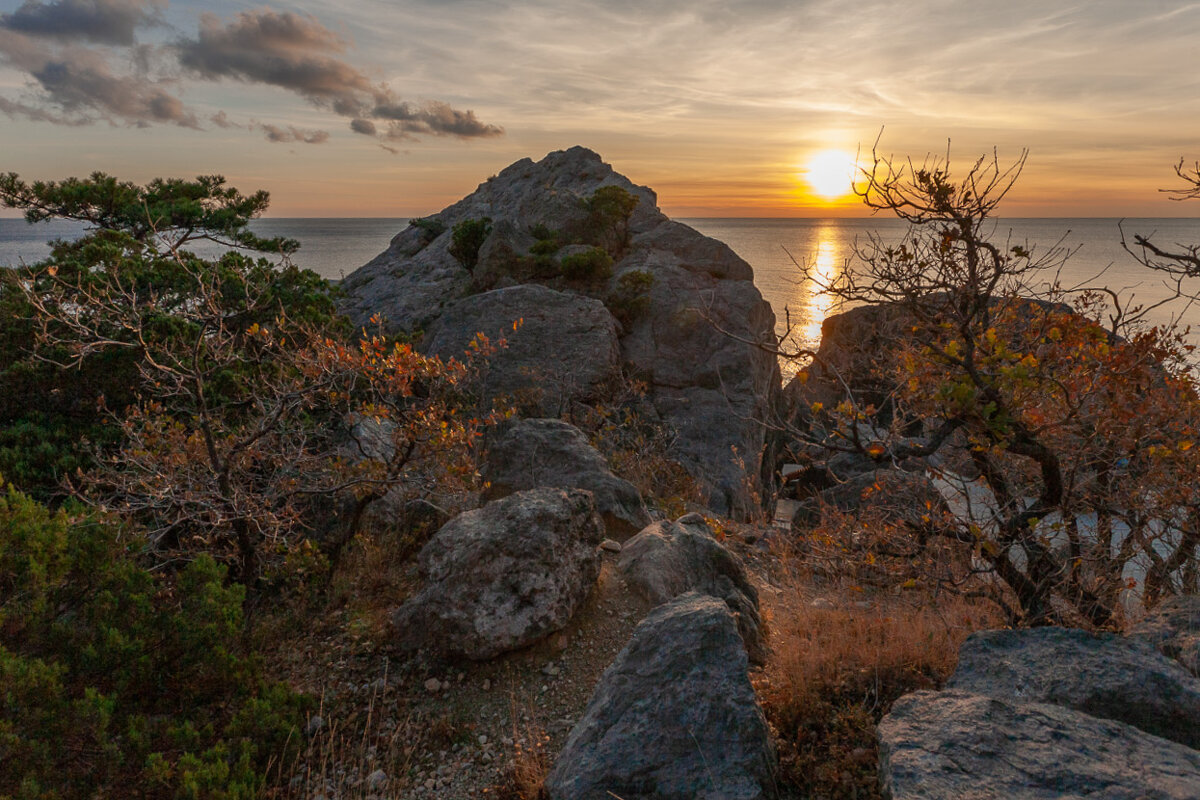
[617,515,767,664]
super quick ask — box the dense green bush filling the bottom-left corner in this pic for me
[0,488,305,800]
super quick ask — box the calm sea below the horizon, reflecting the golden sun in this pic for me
[0,217,1200,348]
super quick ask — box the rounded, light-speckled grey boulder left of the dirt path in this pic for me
[394,488,604,660]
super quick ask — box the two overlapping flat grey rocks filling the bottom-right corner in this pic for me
[877,627,1200,800]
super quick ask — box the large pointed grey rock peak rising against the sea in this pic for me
[342,148,780,513]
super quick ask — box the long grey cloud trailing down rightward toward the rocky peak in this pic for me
[175,8,504,139]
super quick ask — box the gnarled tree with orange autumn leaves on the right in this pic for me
[797,146,1200,626]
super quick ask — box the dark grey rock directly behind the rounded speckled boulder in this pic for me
[481,420,650,539]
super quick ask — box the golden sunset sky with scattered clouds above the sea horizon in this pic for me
[0,0,1200,217]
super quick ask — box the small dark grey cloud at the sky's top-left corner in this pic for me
[0,0,167,46]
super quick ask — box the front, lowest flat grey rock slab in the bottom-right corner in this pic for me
[878,690,1200,800]
